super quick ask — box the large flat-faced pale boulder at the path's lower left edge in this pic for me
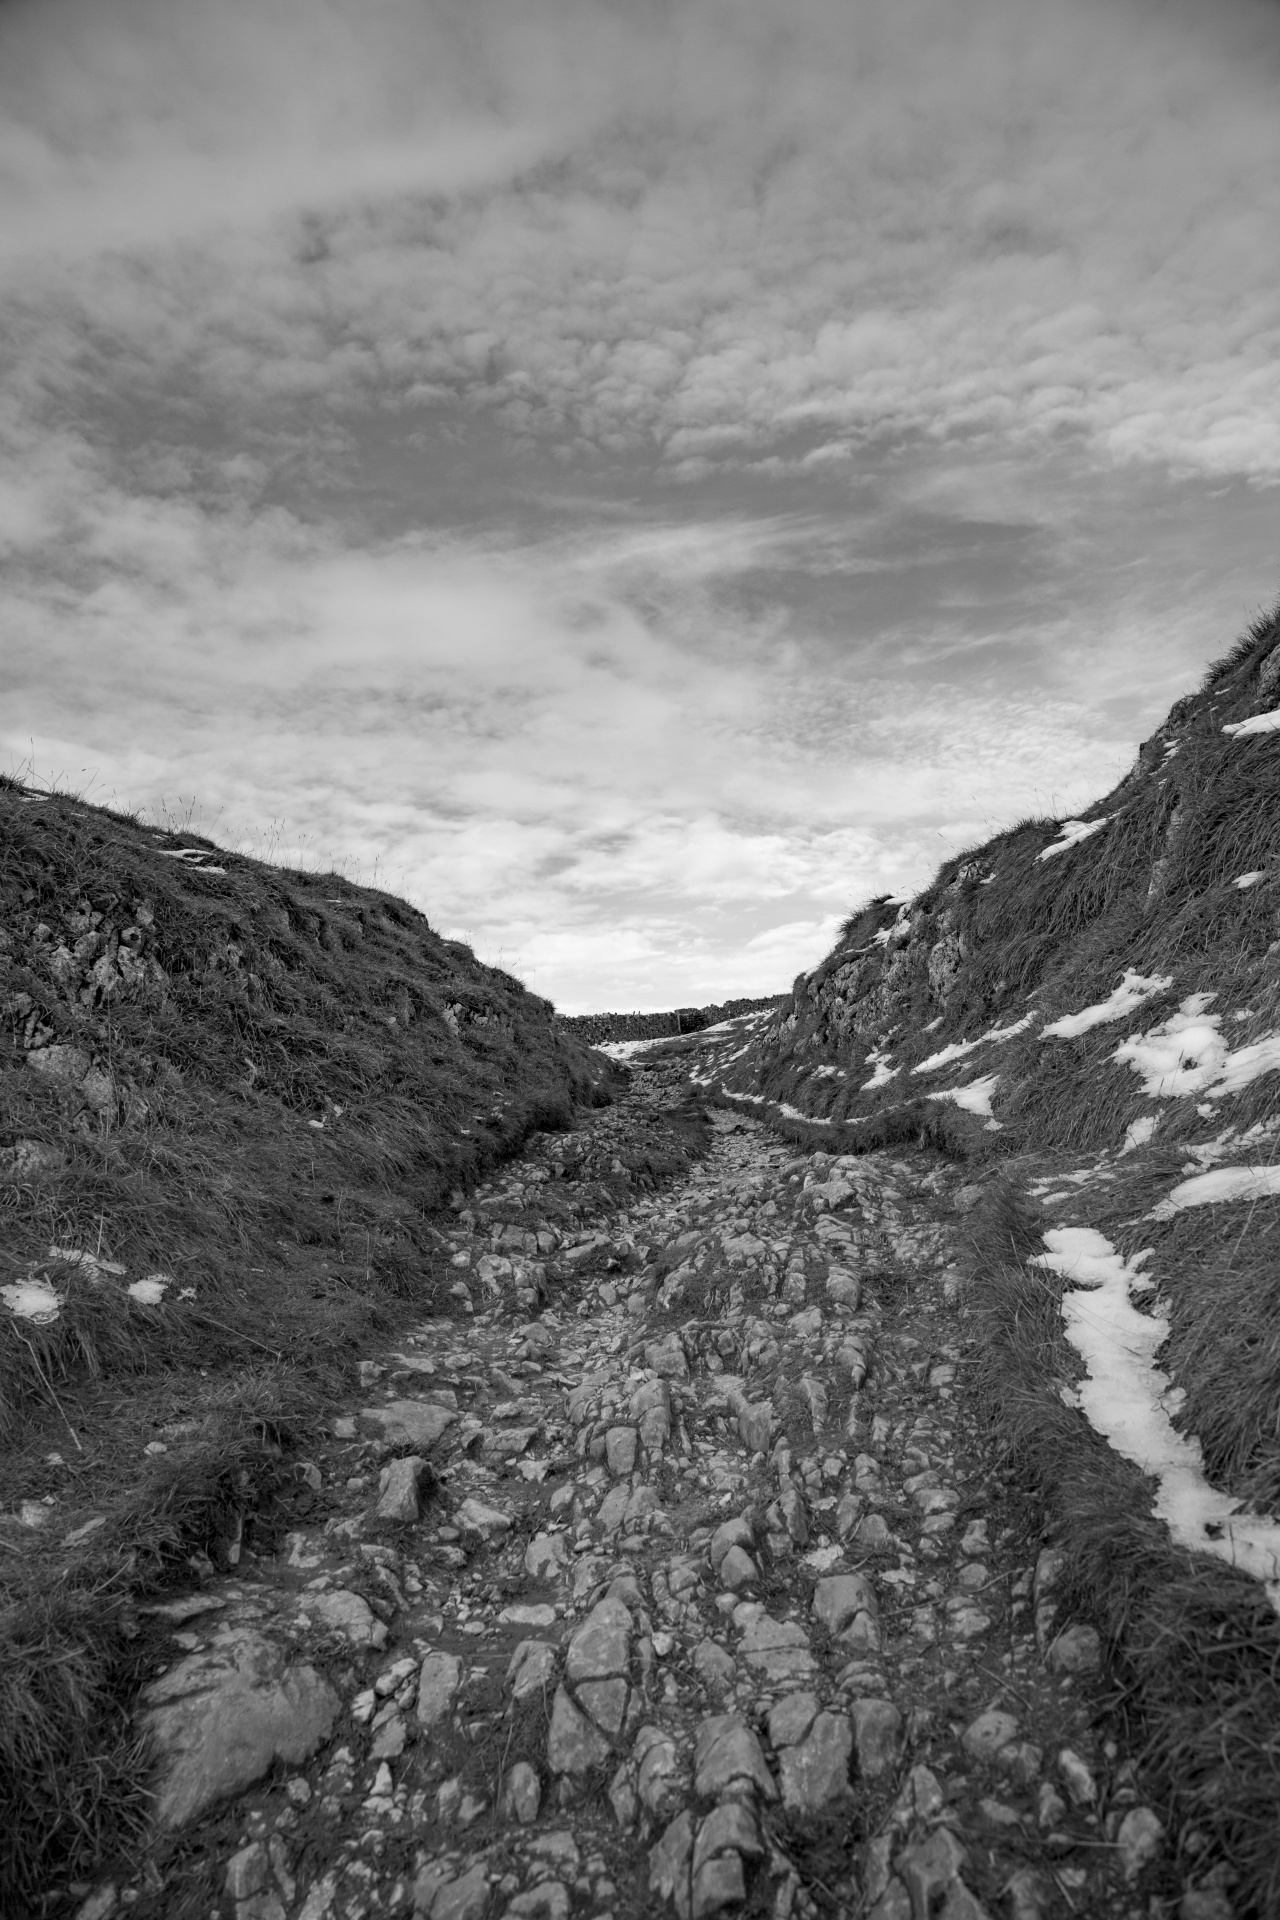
[142,1628,342,1828]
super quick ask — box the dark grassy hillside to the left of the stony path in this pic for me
[0,781,610,1874]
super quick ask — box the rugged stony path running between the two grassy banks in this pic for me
[71,1062,1189,1920]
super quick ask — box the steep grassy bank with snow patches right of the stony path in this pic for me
[704,599,1280,1912]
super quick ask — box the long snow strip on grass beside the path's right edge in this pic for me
[1032,1227,1280,1613]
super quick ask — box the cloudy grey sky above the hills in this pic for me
[0,0,1280,1012]
